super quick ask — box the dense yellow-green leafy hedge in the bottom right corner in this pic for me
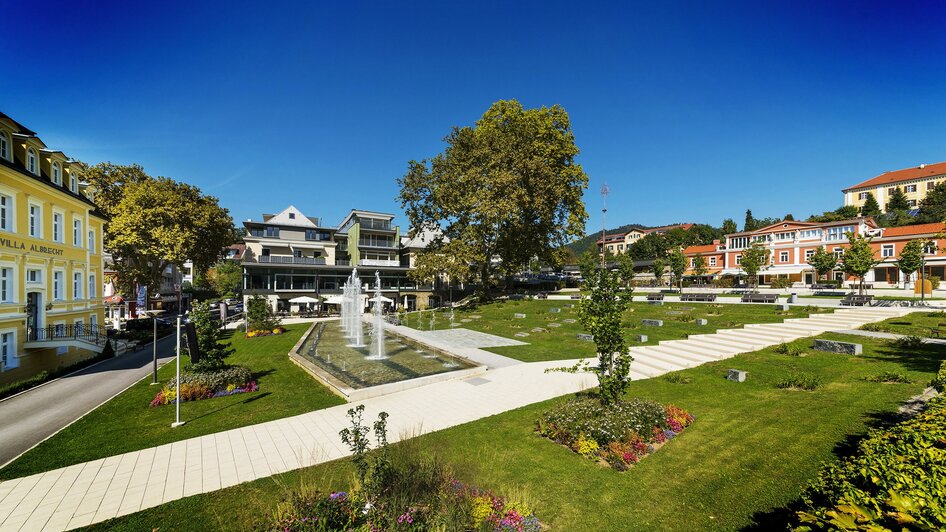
[794,397,946,531]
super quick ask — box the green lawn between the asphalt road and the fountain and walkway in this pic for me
[0,324,344,479]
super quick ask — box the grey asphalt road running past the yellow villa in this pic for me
[0,336,174,465]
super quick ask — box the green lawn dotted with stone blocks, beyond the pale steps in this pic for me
[405,300,832,362]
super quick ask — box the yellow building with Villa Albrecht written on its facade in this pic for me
[0,113,105,384]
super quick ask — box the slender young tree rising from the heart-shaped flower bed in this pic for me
[578,268,634,406]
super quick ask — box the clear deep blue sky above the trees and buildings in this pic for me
[0,1,946,235]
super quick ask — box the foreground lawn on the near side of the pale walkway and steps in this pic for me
[85,335,946,531]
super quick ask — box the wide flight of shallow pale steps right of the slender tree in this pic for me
[630,307,913,379]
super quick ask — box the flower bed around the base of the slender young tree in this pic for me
[536,397,694,471]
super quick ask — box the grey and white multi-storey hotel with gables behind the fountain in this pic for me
[243,206,439,311]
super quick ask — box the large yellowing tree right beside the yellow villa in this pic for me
[85,163,236,293]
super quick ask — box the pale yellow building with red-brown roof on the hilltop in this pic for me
[842,162,946,212]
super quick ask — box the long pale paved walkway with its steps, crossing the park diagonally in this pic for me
[0,308,909,531]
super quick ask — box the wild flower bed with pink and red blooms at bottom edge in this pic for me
[269,479,541,532]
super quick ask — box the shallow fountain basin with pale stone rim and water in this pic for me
[289,321,486,402]
